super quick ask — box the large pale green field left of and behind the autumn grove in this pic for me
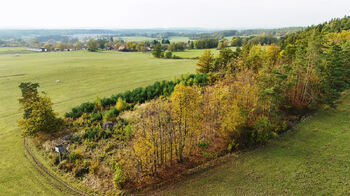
[0,51,195,195]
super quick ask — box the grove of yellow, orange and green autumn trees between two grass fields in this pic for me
[20,17,350,193]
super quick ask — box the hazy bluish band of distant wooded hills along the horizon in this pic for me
[0,27,302,42]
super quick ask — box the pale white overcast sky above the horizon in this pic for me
[0,0,350,29]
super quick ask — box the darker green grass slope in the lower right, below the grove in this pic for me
[162,92,350,195]
